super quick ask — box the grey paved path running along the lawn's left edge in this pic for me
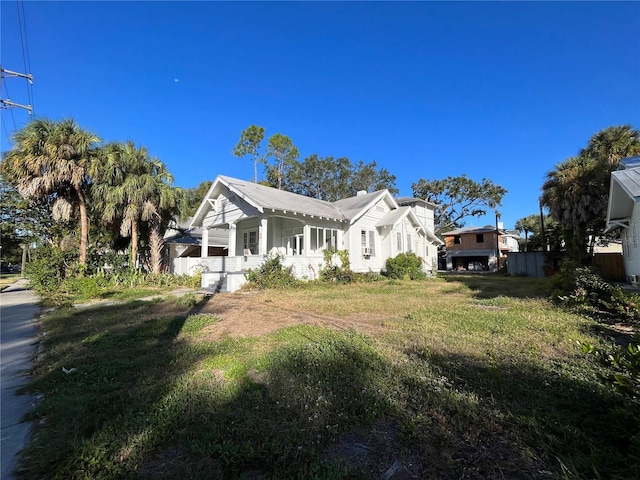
[0,279,38,480]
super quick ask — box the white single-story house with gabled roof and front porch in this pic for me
[184,176,442,291]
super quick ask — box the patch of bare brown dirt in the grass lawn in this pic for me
[194,291,388,341]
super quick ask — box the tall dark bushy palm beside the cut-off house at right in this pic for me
[542,125,640,262]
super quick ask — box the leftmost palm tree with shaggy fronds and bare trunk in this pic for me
[2,119,100,265]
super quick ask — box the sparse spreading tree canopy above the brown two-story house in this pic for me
[411,174,507,234]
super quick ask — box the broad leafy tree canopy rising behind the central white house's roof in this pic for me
[282,153,398,202]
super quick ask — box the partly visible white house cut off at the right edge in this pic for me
[605,155,640,283]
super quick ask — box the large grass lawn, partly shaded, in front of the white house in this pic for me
[19,275,640,479]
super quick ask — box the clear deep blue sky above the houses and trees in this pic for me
[0,1,640,231]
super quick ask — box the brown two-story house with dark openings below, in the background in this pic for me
[443,225,519,270]
